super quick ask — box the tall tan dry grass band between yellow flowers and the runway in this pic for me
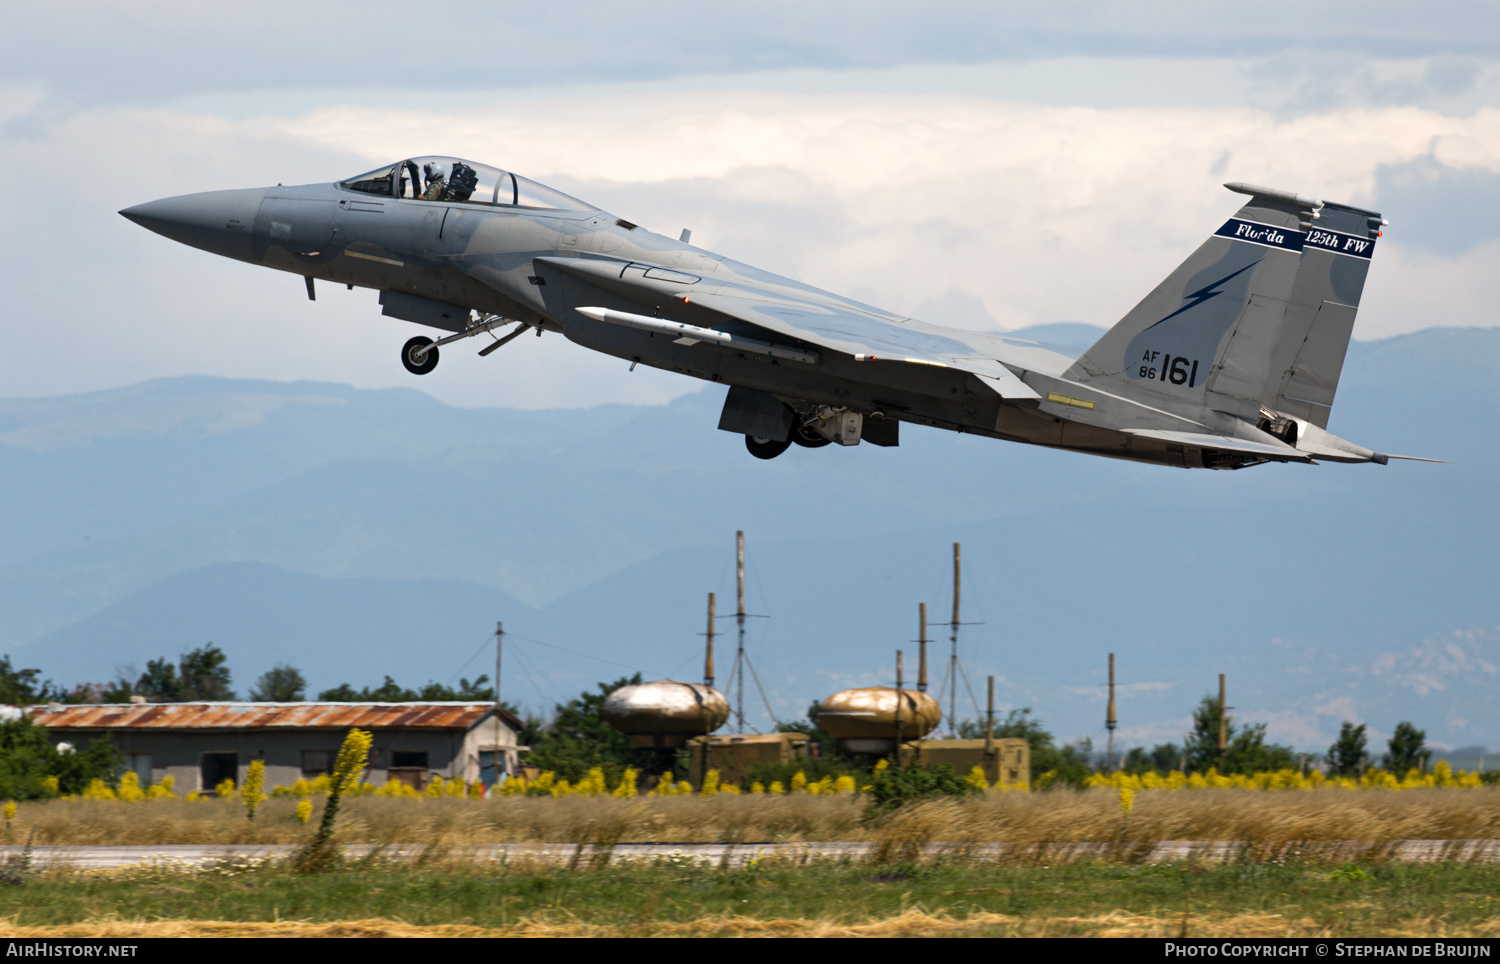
[3,787,1500,846]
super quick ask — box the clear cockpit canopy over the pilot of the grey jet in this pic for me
[339,154,599,211]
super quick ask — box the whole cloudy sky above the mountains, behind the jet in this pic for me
[0,3,1500,408]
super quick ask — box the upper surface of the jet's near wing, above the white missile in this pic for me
[537,258,1041,399]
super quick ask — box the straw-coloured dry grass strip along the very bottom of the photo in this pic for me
[0,909,1500,940]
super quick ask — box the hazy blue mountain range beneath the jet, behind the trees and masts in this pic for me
[0,325,1500,750]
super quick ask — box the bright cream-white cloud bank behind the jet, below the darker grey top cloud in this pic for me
[0,90,1500,408]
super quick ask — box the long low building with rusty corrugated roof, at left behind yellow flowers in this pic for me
[26,703,525,792]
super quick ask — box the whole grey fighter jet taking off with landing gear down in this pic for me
[120,156,1428,469]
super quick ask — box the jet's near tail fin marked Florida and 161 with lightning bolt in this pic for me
[1067,181,1322,421]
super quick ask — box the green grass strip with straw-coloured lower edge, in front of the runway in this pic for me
[0,858,1500,937]
